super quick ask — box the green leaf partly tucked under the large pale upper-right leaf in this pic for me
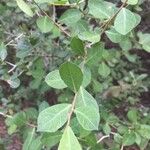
[105,28,125,43]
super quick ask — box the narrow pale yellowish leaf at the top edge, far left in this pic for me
[16,0,33,17]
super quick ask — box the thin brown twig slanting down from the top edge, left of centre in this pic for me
[33,1,71,37]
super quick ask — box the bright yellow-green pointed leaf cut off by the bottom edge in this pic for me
[58,127,82,150]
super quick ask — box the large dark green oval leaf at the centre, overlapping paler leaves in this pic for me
[59,62,83,92]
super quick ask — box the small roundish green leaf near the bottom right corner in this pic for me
[122,131,136,146]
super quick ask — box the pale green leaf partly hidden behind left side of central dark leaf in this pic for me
[45,70,67,89]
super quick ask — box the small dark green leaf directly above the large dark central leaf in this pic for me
[70,37,84,55]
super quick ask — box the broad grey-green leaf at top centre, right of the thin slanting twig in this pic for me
[59,9,82,26]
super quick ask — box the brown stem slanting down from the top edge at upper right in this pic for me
[101,0,128,35]
